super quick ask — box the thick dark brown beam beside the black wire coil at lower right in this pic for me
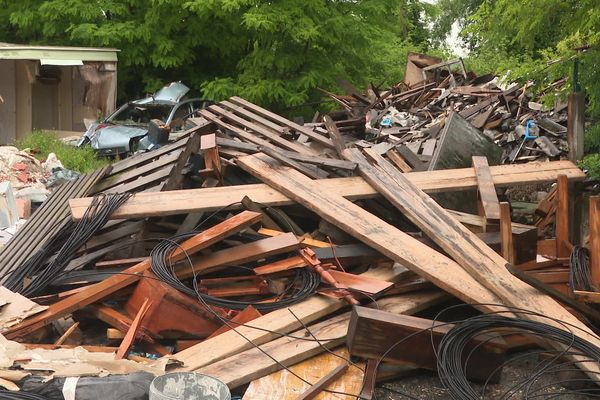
[346,307,505,382]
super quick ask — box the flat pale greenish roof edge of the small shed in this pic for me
[0,42,119,61]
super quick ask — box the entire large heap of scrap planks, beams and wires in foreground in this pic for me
[0,54,600,399]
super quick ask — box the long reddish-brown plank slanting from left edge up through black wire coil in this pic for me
[3,211,261,339]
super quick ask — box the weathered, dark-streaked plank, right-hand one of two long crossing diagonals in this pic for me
[345,149,600,379]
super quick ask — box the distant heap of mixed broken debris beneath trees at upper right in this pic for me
[316,53,569,170]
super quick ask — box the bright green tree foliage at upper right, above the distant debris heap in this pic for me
[436,0,600,151]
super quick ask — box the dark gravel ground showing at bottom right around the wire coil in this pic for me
[375,355,595,400]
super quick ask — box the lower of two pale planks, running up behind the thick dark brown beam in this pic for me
[197,294,436,388]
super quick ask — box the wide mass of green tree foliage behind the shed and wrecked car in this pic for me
[0,0,428,112]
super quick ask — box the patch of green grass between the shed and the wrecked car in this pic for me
[15,131,110,173]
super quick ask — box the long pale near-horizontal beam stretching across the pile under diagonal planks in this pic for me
[69,161,585,220]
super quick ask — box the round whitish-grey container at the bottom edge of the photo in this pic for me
[149,372,231,400]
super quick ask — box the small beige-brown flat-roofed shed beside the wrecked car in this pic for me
[0,43,118,145]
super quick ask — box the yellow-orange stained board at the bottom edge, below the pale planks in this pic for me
[243,347,365,400]
